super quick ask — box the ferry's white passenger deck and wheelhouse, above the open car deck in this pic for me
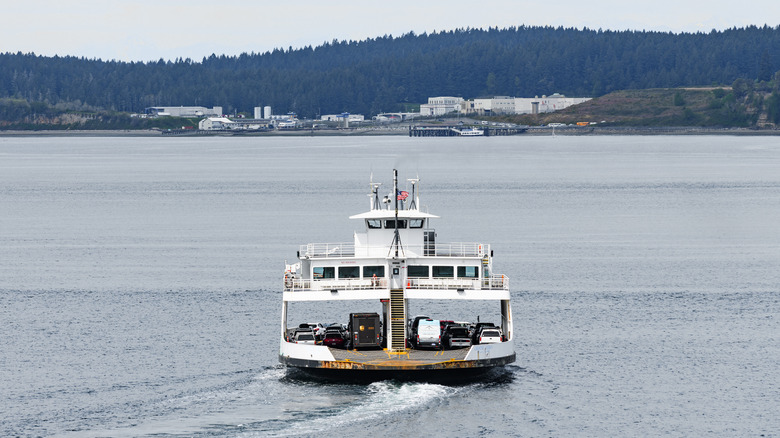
[284,176,509,300]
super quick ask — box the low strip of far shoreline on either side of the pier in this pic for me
[0,125,780,138]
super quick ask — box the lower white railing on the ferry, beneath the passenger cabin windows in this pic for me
[284,275,509,292]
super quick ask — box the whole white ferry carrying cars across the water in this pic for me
[279,170,515,380]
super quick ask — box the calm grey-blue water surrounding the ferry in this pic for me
[0,137,780,437]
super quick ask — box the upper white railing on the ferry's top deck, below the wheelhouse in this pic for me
[299,242,490,259]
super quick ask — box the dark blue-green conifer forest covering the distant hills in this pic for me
[0,26,780,117]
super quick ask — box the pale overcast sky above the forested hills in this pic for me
[6,0,780,61]
